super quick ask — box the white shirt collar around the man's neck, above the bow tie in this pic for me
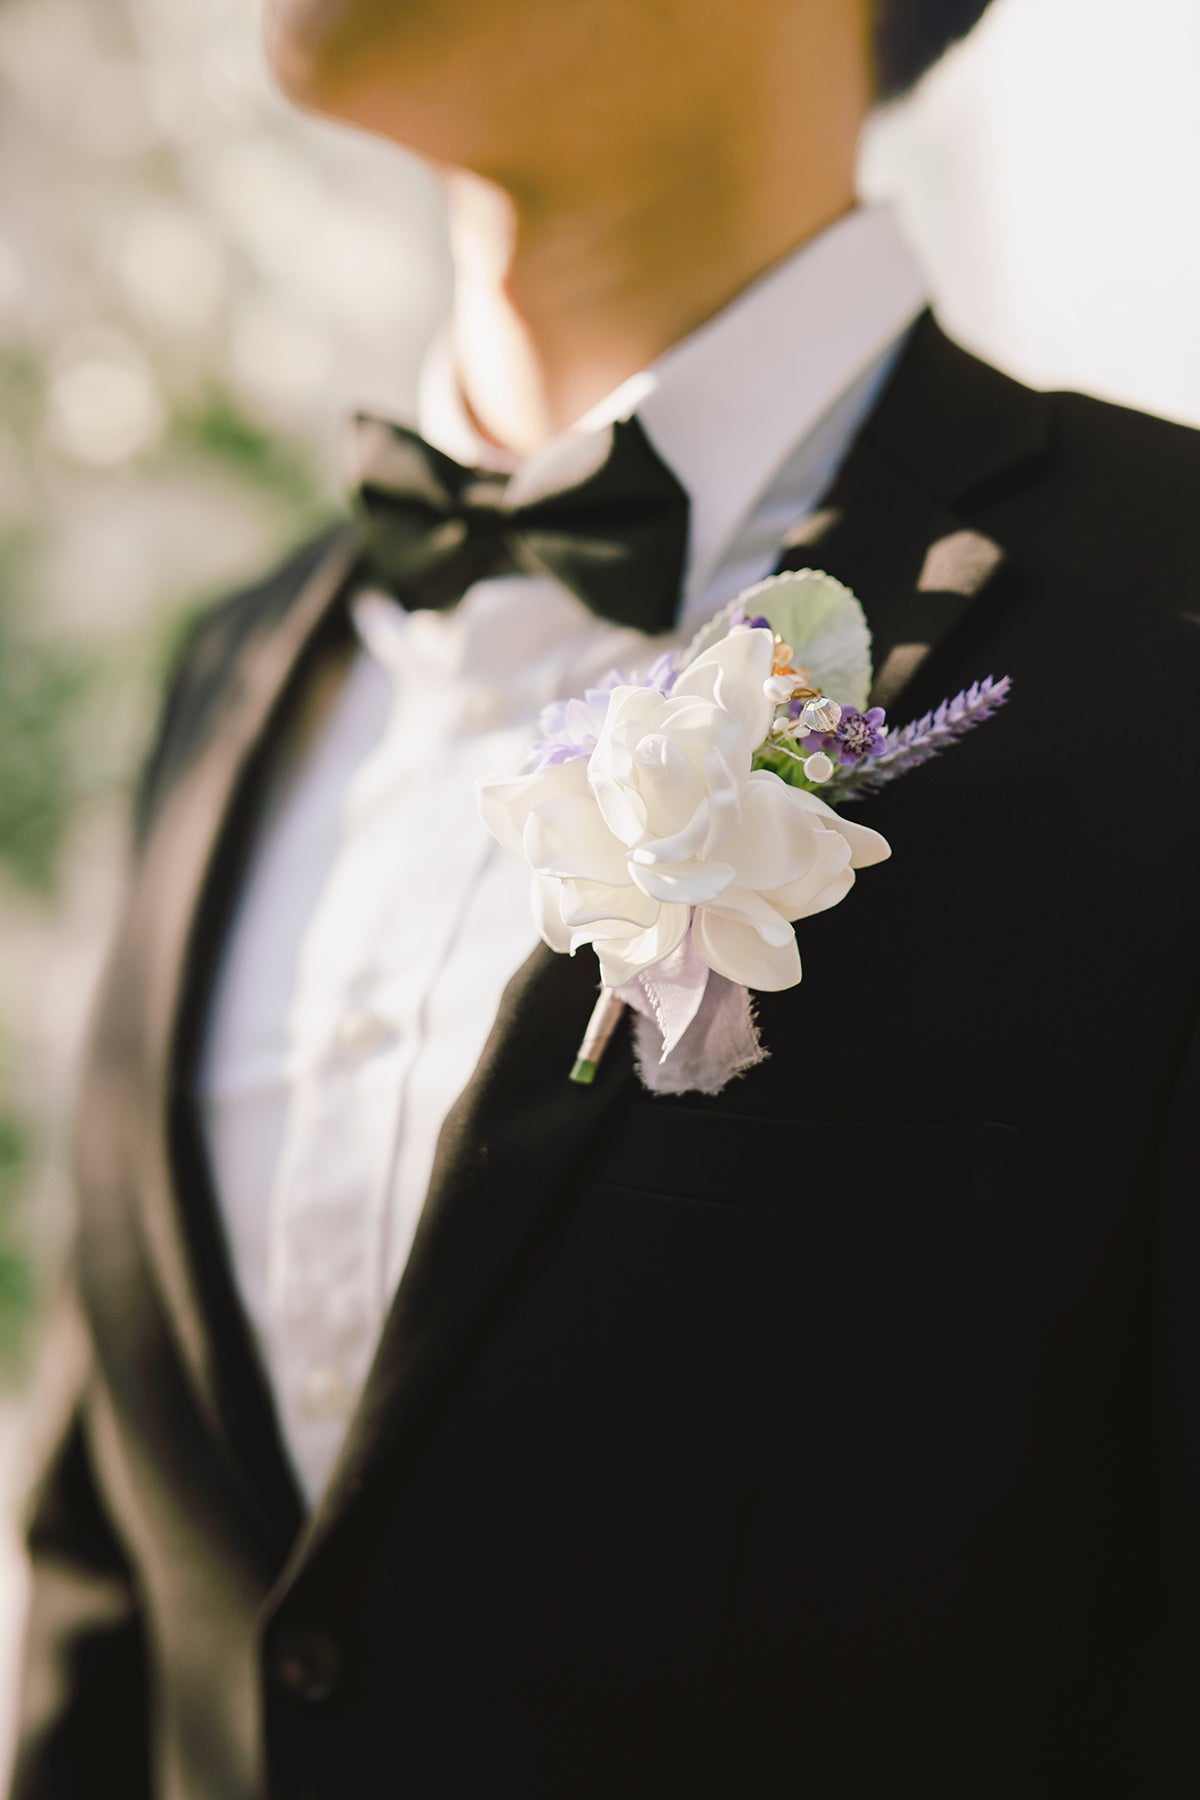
[417,205,927,607]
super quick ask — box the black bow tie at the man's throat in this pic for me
[353,414,687,632]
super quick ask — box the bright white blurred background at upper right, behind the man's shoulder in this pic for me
[862,0,1200,425]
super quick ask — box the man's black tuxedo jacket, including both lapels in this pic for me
[14,319,1200,1800]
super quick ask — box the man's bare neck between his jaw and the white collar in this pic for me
[448,69,862,452]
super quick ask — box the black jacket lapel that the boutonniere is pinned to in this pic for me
[282,317,1042,1586]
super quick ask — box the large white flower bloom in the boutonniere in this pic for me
[479,630,891,990]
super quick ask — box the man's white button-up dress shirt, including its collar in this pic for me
[198,209,925,1503]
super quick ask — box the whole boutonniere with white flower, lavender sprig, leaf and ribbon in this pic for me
[477,569,1009,1094]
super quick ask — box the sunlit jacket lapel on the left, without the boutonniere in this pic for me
[99,533,367,1561]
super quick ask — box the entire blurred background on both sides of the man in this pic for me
[0,0,1200,1778]
